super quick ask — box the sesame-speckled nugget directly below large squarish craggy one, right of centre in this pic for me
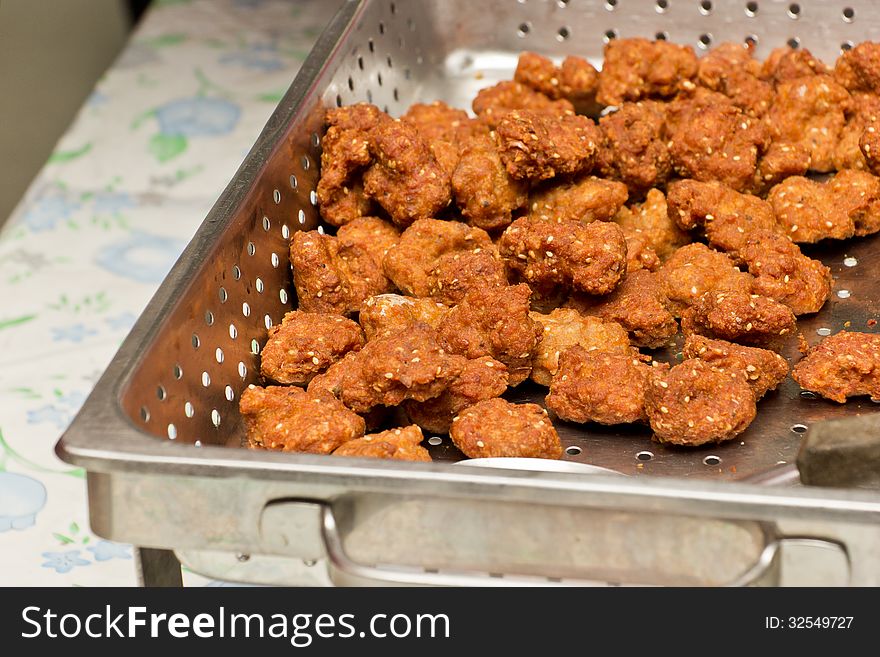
[666,180,778,260]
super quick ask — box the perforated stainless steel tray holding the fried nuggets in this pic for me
[57,0,880,584]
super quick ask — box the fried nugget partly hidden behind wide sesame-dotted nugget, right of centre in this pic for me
[657,242,752,316]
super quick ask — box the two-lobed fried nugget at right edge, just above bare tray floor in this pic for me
[767,169,880,244]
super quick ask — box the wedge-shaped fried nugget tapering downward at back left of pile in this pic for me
[400,100,487,177]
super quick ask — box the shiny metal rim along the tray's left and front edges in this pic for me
[55,0,880,522]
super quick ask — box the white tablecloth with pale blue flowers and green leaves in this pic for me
[0,0,338,586]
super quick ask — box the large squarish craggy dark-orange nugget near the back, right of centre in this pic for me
[667,100,769,191]
